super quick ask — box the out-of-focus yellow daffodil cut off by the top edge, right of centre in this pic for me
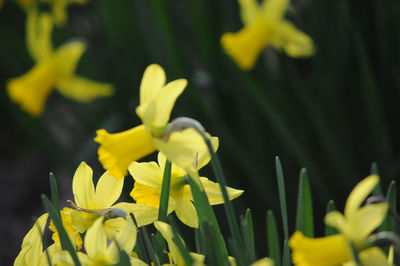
[221,0,314,70]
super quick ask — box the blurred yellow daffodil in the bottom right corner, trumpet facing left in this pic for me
[289,175,389,266]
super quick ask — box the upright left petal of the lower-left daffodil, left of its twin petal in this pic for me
[72,162,96,209]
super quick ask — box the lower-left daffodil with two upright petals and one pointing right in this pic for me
[70,162,158,235]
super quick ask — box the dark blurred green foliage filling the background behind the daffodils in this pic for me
[0,0,400,264]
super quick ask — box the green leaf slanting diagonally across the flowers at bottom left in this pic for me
[42,194,81,266]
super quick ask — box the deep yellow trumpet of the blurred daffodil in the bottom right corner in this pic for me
[289,232,350,266]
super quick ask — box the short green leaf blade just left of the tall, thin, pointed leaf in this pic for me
[267,210,281,266]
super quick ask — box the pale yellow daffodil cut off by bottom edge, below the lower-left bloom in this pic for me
[78,216,146,266]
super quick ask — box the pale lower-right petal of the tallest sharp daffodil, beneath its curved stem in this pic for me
[153,128,214,176]
